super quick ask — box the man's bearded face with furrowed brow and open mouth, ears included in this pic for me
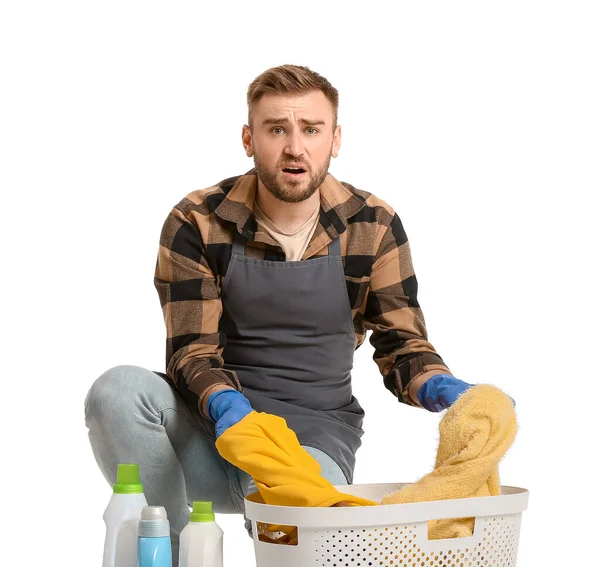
[242,91,341,203]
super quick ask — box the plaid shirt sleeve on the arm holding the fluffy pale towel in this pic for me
[365,213,450,406]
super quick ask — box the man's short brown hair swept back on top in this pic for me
[246,65,339,129]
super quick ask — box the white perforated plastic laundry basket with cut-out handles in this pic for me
[245,484,529,567]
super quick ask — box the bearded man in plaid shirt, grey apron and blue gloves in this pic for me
[86,65,478,555]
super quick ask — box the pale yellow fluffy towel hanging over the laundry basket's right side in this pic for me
[382,384,517,539]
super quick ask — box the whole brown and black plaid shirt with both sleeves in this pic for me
[154,169,450,412]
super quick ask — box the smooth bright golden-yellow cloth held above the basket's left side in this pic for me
[216,411,376,506]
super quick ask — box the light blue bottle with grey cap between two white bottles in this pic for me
[138,506,172,567]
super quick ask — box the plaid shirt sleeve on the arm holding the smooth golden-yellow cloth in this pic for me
[154,204,241,413]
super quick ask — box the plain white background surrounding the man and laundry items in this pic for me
[0,0,600,567]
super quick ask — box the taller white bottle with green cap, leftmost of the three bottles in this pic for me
[102,464,148,567]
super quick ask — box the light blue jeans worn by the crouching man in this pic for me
[85,366,347,567]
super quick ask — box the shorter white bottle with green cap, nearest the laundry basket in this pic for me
[179,502,223,567]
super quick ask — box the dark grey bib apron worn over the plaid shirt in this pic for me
[219,229,364,483]
